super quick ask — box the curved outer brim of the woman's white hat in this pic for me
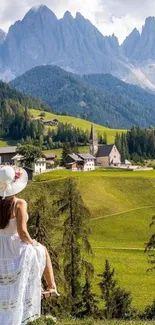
[0,167,28,197]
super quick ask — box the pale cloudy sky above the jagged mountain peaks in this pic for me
[0,0,155,44]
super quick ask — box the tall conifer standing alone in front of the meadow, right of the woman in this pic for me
[55,178,93,316]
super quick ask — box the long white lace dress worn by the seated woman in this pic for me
[0,200,46,325]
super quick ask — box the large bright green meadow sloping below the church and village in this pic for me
[31,170,155,310]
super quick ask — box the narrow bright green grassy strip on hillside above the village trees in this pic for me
[30,109,126,143]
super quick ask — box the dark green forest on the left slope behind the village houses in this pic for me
[0,92,93,149]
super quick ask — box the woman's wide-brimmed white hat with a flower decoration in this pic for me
[0,166,28,199]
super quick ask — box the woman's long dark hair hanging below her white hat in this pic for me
[0,196,14,229]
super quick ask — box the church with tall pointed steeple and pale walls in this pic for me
[89,124,121,167]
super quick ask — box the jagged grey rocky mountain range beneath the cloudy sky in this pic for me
[0,5,155,91]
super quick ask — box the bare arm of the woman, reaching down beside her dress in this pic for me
[16,199,33,245]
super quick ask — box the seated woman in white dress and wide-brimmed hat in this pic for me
[0,166,59,325]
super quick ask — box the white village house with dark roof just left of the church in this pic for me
[65,153,96,171]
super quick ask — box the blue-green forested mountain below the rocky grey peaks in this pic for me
[10,65,155,128]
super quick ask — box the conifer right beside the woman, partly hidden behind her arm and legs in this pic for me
[27,193,62,316]
